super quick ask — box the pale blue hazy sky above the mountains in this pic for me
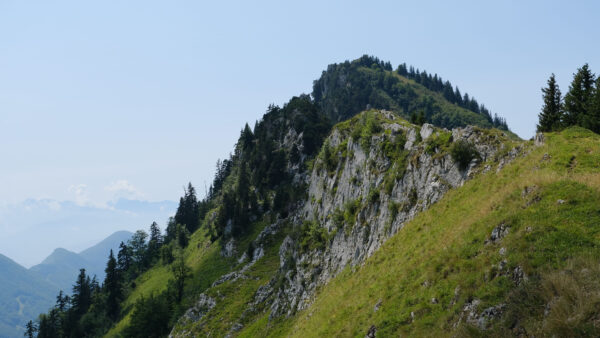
[0,0,600,265]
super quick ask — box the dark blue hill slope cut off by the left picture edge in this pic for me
[0,254,58,337]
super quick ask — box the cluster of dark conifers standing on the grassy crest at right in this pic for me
[537,63,600,133]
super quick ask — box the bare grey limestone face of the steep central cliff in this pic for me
[263,112,518,317]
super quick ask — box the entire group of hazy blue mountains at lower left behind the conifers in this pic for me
[0,231,133,337]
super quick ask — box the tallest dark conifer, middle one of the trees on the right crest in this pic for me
[564,63,594,126]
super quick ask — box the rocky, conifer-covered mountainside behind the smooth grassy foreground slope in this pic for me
[31,57,523,337]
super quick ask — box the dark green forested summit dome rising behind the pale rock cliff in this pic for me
[312,55,508,130]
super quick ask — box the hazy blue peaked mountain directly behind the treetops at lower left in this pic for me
[30,231,133,294]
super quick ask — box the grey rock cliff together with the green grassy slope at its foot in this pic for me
[166,111,515,336]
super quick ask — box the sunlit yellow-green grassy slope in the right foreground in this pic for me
[241,128,600,337]
